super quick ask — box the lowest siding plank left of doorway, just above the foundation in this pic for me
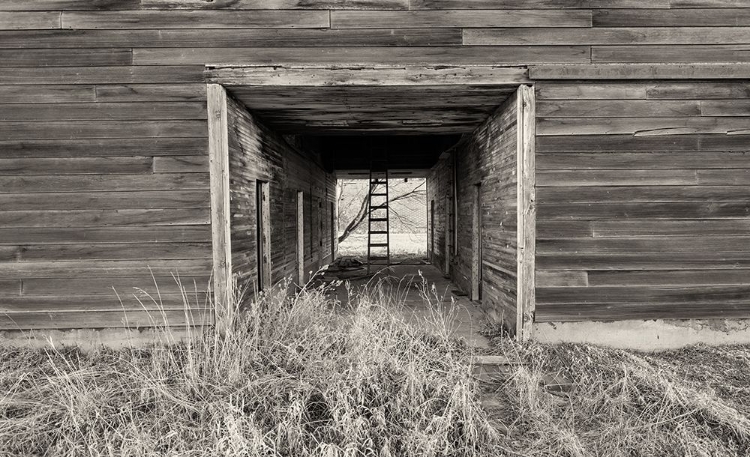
[0,308,212,330]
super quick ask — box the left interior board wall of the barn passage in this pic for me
[227,97,336,292]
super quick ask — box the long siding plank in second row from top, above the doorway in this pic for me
[331,9,591,29]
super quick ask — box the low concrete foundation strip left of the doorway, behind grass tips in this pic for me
[0,328,194,351]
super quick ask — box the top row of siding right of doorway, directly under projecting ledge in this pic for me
[536,81,750,100]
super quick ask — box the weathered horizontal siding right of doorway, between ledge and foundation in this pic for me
[536,81,750,322]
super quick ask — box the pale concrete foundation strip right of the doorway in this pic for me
[532,319,750,351]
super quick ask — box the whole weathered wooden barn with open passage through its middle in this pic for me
[0,0,750,346]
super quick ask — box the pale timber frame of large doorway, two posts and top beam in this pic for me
[204,64,536,340]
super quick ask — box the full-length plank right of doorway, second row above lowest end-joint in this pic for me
[537,234,750,255]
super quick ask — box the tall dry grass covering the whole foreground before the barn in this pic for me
[0,278,750,456]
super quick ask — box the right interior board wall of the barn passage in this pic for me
[428,94,518,329]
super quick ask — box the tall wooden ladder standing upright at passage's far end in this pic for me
[367,160,391,274]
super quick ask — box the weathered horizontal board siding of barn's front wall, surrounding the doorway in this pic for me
[0,0,750,329]
